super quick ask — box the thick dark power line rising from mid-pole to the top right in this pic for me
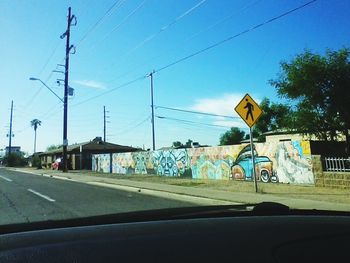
[155,0,317,73]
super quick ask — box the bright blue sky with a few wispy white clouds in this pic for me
[0,0,350,153]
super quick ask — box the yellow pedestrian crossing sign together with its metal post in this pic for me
[235,94,262,193]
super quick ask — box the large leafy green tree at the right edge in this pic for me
[270,48,350,145]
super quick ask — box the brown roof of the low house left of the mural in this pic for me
[39,137,141,155]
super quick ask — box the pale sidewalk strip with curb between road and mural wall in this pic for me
[7,168,350,211]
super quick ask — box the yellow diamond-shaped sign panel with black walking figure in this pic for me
[235,93,262,128]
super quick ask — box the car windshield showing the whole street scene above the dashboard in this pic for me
[0,0,350,225]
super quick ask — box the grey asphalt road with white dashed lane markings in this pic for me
[0,168,193,225]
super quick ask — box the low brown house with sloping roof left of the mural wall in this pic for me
[39,137,140,170]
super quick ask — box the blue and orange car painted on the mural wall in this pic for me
[231,145,278,183]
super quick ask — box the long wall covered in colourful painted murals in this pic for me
[93,141,314,184]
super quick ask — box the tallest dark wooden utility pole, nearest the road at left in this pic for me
[61,7,77,172]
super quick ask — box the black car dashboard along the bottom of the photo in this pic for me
[0,206,350,263]
